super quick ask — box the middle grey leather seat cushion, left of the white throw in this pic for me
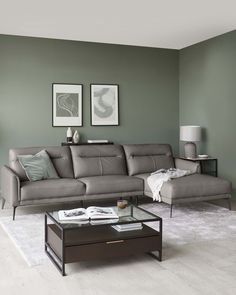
[79,175,143,195]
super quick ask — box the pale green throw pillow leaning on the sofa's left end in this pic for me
[17,150,59,181]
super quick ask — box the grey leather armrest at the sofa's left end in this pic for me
[1,166,20,206]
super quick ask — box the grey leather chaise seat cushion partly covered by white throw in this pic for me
[137,173,231,199]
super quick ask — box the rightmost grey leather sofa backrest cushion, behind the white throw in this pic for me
[123,144,174,175]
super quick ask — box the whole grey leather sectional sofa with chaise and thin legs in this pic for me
[1,144,231,219]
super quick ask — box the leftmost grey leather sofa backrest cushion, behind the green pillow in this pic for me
[9,146,74,181]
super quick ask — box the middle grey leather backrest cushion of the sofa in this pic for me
[70,145,127,178]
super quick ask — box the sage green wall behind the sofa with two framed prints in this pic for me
[0,35,179,169]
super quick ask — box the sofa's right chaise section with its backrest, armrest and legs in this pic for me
[124,144,232,216]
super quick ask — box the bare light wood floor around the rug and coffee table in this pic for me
[0,201,236,295]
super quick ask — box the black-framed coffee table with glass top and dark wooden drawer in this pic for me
[45,205,162,276]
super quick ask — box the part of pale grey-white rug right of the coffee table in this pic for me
[141,202,236,247]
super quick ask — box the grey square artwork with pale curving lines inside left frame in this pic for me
[56,93,79,117]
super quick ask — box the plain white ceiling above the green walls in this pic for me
[0,0,236,49]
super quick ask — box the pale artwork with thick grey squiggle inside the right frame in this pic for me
[94,87,116,119]
